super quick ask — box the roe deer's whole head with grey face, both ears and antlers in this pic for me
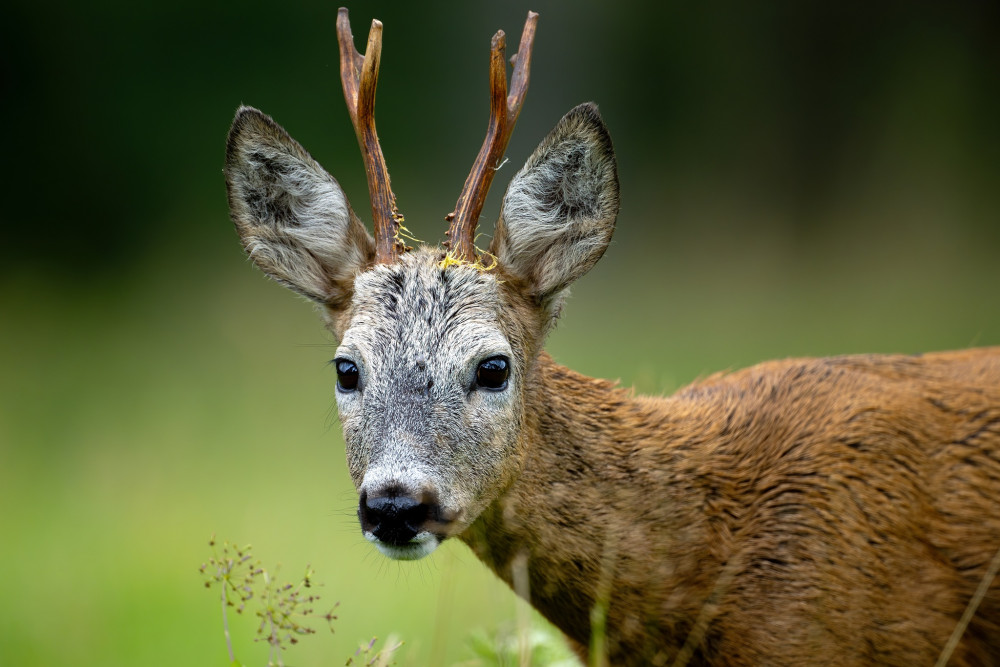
[225,9,618,559]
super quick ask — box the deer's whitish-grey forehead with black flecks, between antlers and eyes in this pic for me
[341,248,510,366]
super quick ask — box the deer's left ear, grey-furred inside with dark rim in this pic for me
[225,107,375,308]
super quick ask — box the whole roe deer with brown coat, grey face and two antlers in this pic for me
[225,9,1000,665]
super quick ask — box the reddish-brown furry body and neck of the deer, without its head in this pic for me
[462,348,1000,665]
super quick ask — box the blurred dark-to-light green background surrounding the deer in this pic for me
[0,0,1000,666]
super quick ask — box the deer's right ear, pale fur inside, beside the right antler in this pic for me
[490,103,618,304]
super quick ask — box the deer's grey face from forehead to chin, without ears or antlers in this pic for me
[335,249,530,559]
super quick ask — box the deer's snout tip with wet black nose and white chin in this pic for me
[358,488,448,560]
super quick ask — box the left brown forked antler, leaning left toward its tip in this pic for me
[337,7,405,264]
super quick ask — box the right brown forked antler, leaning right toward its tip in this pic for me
[445,12,538,262]
